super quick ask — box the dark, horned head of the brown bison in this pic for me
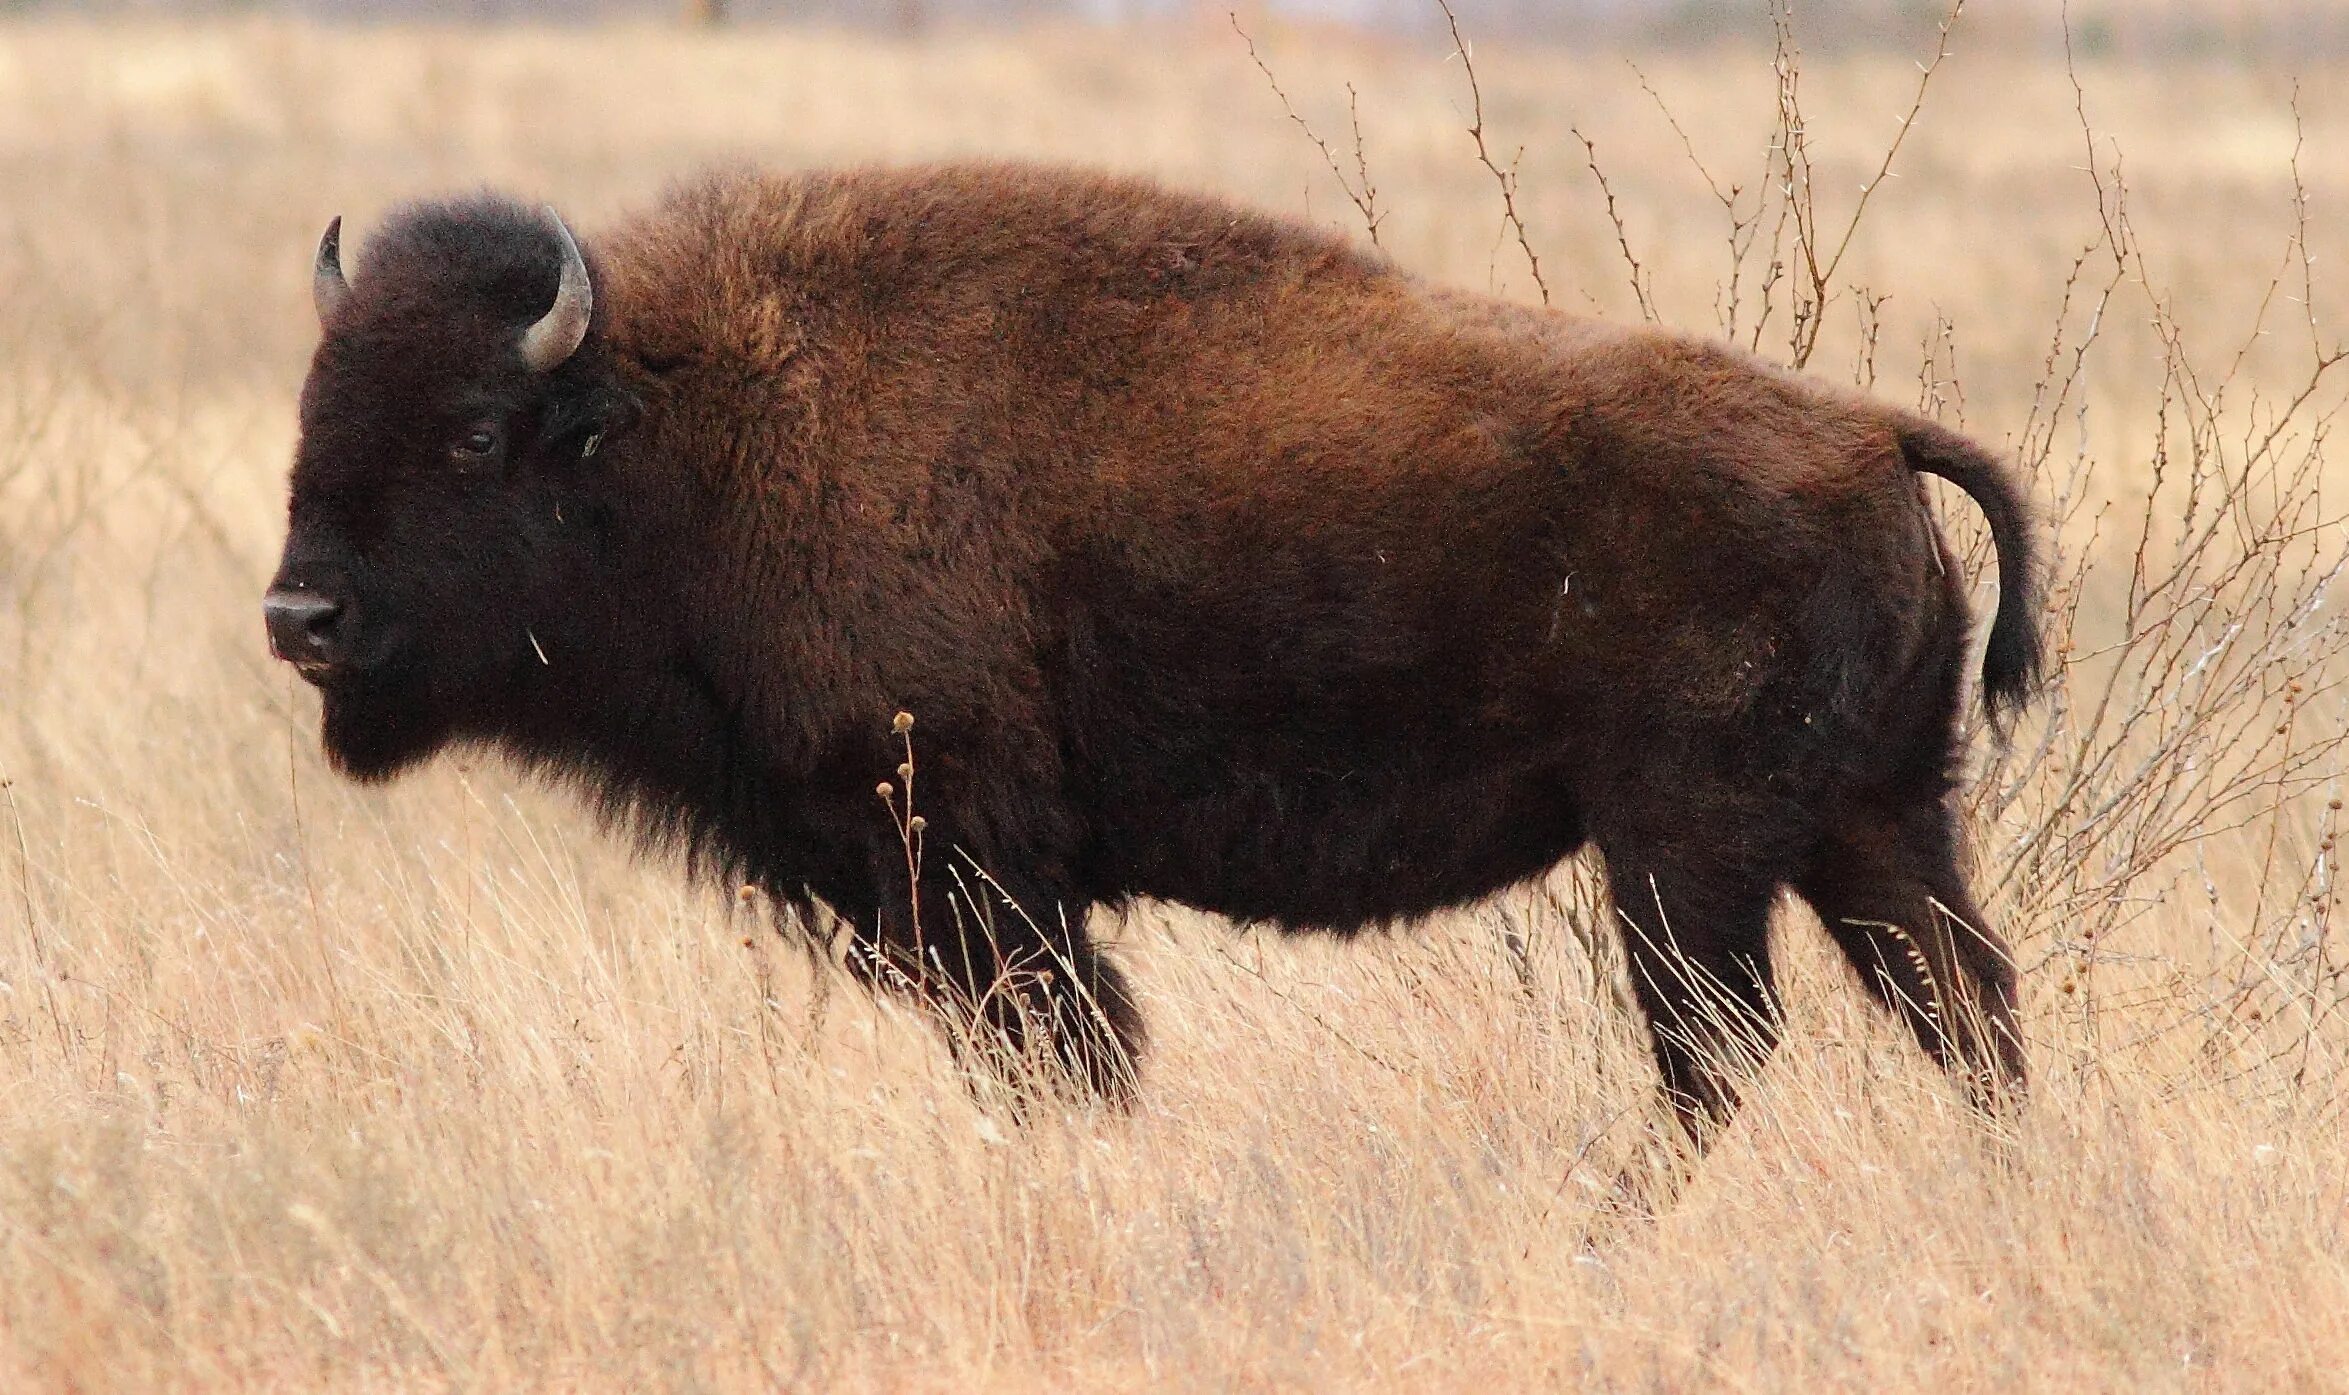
[261,200,625,780]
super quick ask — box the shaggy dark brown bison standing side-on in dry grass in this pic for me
[263,164,2041,1160]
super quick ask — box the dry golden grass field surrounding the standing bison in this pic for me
[0,21,2349,1390]
